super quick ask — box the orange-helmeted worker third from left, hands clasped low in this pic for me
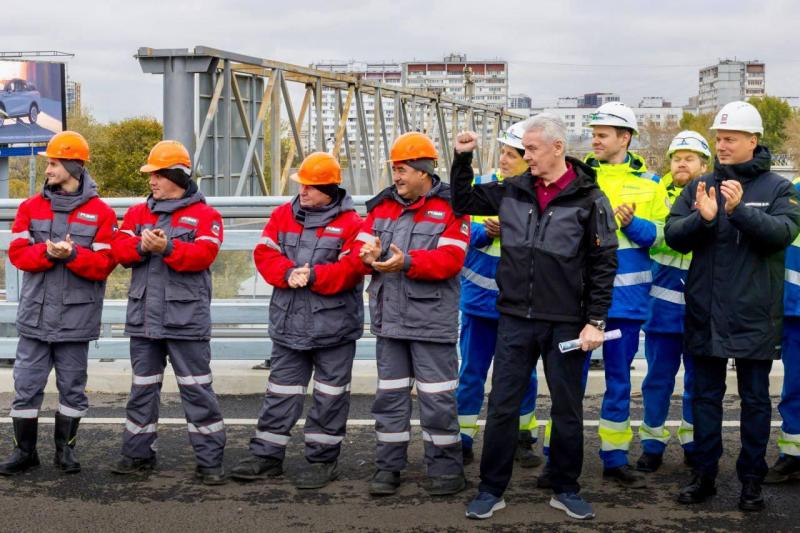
[231,152,364,489]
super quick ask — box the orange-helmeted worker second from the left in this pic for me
[111,141,226,485]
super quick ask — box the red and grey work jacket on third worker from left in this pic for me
[253,191,364,350]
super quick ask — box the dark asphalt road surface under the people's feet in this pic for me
[0,394,800,533]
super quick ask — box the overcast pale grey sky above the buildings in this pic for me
[6,0,800,120]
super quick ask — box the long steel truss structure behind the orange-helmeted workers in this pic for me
[135,46,525,196]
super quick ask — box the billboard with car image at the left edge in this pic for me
[0,60,67,145]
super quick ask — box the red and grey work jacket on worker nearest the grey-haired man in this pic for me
[354,176,470,343]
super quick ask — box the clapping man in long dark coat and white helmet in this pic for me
[665,102,800,511]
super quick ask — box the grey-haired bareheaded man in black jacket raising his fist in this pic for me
[451,114,617,519]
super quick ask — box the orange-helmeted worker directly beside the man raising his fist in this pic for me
[358,132,470,495]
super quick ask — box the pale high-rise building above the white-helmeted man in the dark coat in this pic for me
[698,59,766,113]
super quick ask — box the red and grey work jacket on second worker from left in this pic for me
[112,182,222,340]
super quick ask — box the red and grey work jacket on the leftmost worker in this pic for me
[8,171,117,342]
